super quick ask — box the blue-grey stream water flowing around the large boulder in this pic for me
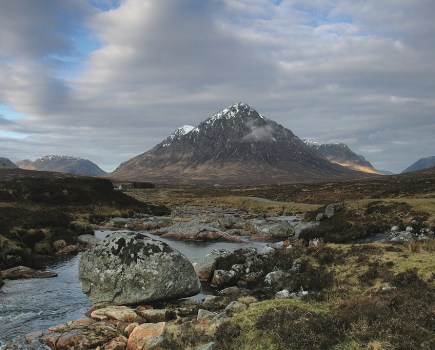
[0,231,265,349]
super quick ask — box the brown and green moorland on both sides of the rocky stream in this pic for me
[0,168,435,350]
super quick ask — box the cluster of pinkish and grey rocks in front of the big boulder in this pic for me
[22,296,257,350]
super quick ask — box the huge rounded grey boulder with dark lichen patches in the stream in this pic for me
[79,232,201,306]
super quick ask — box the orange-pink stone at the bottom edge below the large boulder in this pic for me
[127,322,166,350]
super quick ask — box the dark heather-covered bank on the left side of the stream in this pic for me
[0,169,169,269]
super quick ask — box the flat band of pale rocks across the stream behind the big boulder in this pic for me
[105,206,316,242]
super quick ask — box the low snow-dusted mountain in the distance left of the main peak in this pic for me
[17,155,106,176]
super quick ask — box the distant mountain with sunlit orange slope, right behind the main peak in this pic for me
[304,140,383,175]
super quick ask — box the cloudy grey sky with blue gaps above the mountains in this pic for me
[0,0,435,172]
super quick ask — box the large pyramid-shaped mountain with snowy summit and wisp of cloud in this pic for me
[110,103,370,184]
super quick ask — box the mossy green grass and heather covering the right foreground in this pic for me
[164,240,435,350]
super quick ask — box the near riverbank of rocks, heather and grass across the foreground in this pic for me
[6,235,435,350]
